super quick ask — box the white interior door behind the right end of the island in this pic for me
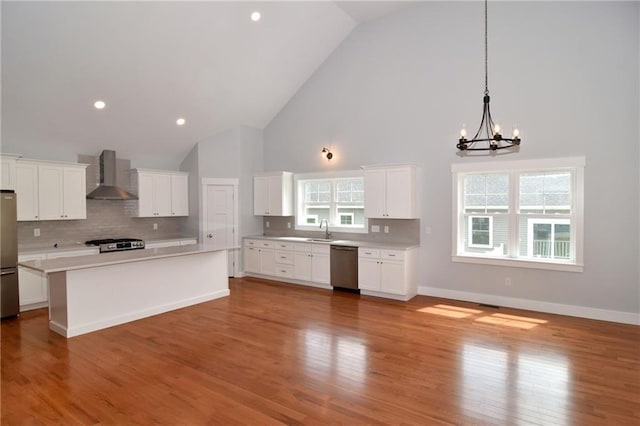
[202,184,236,275]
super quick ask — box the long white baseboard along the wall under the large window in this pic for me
[418,287,640,325]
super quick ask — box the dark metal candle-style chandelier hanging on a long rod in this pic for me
[456,0,520,151]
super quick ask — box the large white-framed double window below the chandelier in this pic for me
[451,157,584,271]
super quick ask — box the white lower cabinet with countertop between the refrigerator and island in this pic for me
[18,247,100,312]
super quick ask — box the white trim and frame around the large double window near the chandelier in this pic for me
[451,157,586,272]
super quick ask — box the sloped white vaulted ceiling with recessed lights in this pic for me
[1,1,407,168]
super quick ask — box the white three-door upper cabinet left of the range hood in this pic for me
[16,160,87,221]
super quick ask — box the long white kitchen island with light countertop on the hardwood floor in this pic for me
[19,245,233,337]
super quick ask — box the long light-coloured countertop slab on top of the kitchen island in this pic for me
[18,244,239,274]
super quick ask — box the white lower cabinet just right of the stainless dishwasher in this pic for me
[358,247,418,300]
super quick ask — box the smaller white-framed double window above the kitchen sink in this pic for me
[295,172,366,232]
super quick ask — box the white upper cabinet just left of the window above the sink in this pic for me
[253,172,293,216]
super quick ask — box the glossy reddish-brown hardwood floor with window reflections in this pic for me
[1,278,640,425]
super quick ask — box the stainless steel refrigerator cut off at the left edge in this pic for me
[0,189,20,318]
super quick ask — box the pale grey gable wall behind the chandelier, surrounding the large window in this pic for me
[264,2,640,322]
